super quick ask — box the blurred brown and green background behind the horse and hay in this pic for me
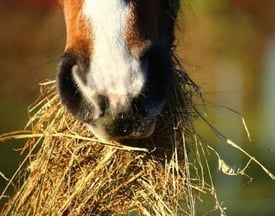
[0,0,275,215]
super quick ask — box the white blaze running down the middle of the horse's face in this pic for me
[79,0,145,105]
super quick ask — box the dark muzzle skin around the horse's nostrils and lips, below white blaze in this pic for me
[57,47,172,141]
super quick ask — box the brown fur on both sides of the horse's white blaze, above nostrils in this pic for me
[60,0,161,57]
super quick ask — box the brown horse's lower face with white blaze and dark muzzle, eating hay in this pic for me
[57,0,179,141]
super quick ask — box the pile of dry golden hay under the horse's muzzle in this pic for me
[1,66,226,216]
